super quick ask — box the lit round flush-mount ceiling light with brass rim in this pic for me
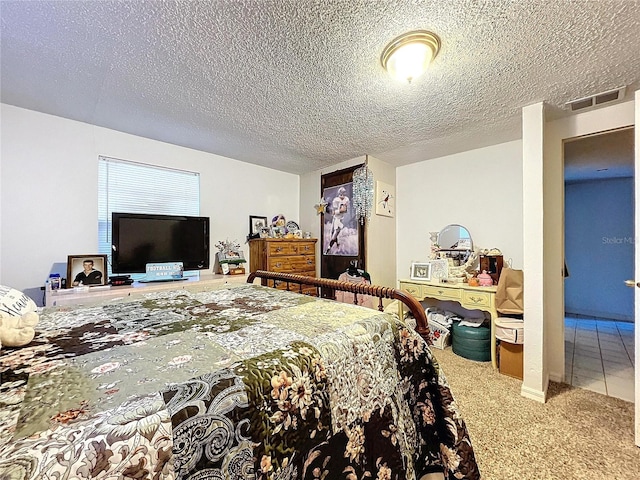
[380,30,440,83]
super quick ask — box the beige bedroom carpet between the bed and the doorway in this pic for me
[433,348,640,480]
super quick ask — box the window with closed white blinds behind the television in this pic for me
[98,156,200,275]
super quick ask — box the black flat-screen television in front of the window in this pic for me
[111,212,209,274]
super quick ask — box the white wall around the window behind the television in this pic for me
[0,104,300,301]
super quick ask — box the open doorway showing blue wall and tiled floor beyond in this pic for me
[563,127,635,402]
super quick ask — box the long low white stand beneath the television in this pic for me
[45,273,247,307]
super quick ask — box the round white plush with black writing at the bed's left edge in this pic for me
[0,285,40,347]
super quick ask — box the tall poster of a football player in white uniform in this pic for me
[322,182,358,256]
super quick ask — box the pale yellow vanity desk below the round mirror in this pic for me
[400,279,498,368]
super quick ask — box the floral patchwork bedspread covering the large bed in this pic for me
[0,285,480,480]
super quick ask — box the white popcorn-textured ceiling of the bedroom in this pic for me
[0,0,640,173]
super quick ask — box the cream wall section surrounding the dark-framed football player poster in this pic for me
[300,156,397,287]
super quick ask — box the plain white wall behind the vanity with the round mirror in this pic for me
[396,140,523,279]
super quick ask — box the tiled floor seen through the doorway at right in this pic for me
[564,316,635,402]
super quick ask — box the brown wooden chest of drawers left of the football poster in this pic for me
[249,238,318,293]
